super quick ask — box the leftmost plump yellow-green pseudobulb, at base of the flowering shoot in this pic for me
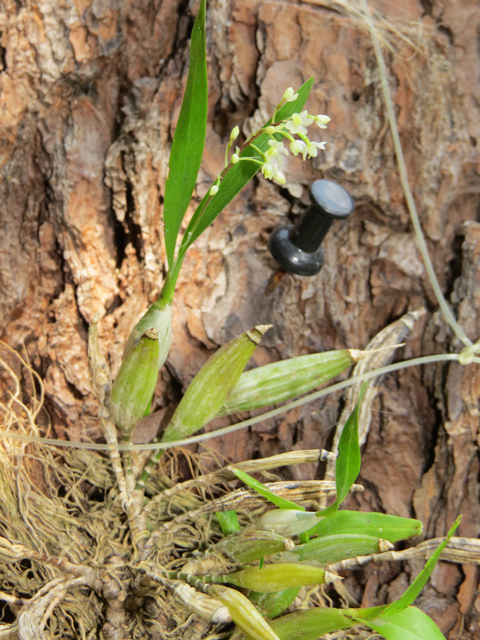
[110,327,159,436]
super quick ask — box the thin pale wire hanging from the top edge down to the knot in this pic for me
[362,0,473,347]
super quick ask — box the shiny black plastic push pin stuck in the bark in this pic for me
[268,180,355,276]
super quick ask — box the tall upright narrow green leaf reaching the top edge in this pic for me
[163,0,208,269]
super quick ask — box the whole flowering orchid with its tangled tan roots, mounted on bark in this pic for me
[0,0,479,640]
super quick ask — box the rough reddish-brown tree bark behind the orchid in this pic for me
[0,0,480,640]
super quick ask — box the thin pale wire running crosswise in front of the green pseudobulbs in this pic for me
[0,353,459,451]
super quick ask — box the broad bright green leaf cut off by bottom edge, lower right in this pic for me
[350,601,445,640]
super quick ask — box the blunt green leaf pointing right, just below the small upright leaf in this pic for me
[309,509,422,542]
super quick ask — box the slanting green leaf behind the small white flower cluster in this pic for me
[182,78,313,251]
